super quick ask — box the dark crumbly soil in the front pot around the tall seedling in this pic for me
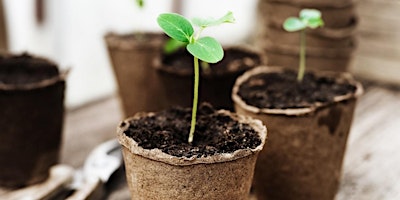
[124,104,261,158]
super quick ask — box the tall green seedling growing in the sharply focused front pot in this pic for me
[157,12,235,143]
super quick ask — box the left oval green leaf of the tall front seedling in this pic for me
[157,13,194,43]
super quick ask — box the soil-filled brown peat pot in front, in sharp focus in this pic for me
[117,106,267,200]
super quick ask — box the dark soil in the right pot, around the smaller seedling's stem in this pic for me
[239,71,356,109]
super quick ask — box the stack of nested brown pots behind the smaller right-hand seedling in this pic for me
[257,0,357,72]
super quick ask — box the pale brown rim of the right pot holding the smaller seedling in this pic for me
[232,66,363,116]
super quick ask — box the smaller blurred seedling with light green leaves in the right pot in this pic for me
[283,9,324,82]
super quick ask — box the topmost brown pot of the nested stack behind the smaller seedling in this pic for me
[259,1,357,29]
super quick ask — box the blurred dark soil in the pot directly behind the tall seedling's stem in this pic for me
[162,48,261,75]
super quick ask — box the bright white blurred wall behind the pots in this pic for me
[4,0,257,107]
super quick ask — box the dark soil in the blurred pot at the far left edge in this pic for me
[0,54,59,85]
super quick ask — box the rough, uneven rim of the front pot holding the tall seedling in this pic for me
[117,110,267,166]
